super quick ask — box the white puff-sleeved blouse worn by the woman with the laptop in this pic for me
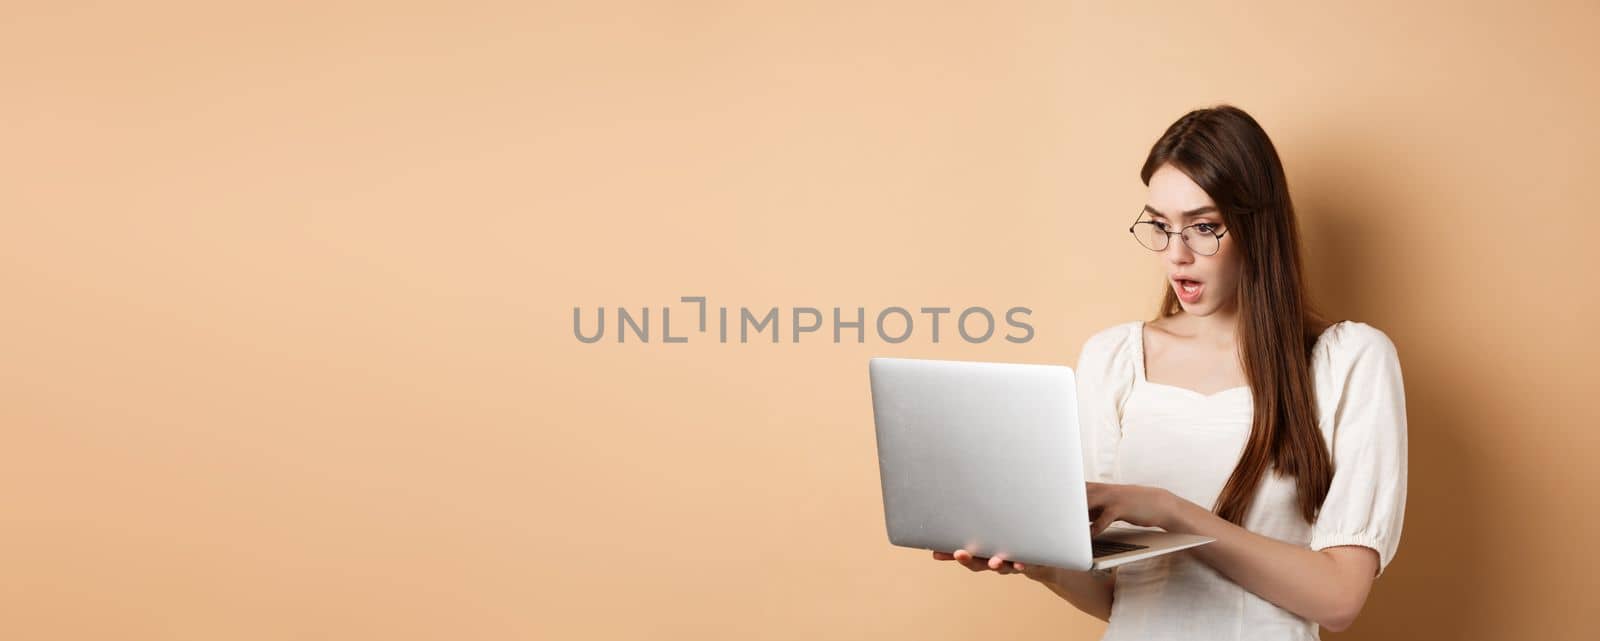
[1077,321,1406,641]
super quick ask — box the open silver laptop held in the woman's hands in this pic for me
[867,358,1216,572]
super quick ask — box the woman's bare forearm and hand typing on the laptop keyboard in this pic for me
[1164,496,1378,631]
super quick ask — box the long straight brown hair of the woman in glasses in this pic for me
[1139,104,1333,526]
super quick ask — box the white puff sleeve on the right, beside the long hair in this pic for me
[1310,323,1406,579]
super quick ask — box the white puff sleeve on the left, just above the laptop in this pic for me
[1075,324,1138,483]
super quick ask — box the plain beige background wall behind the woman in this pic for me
[0,2,1600,639]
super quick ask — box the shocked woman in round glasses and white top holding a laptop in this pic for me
[933,106,1406,639]
